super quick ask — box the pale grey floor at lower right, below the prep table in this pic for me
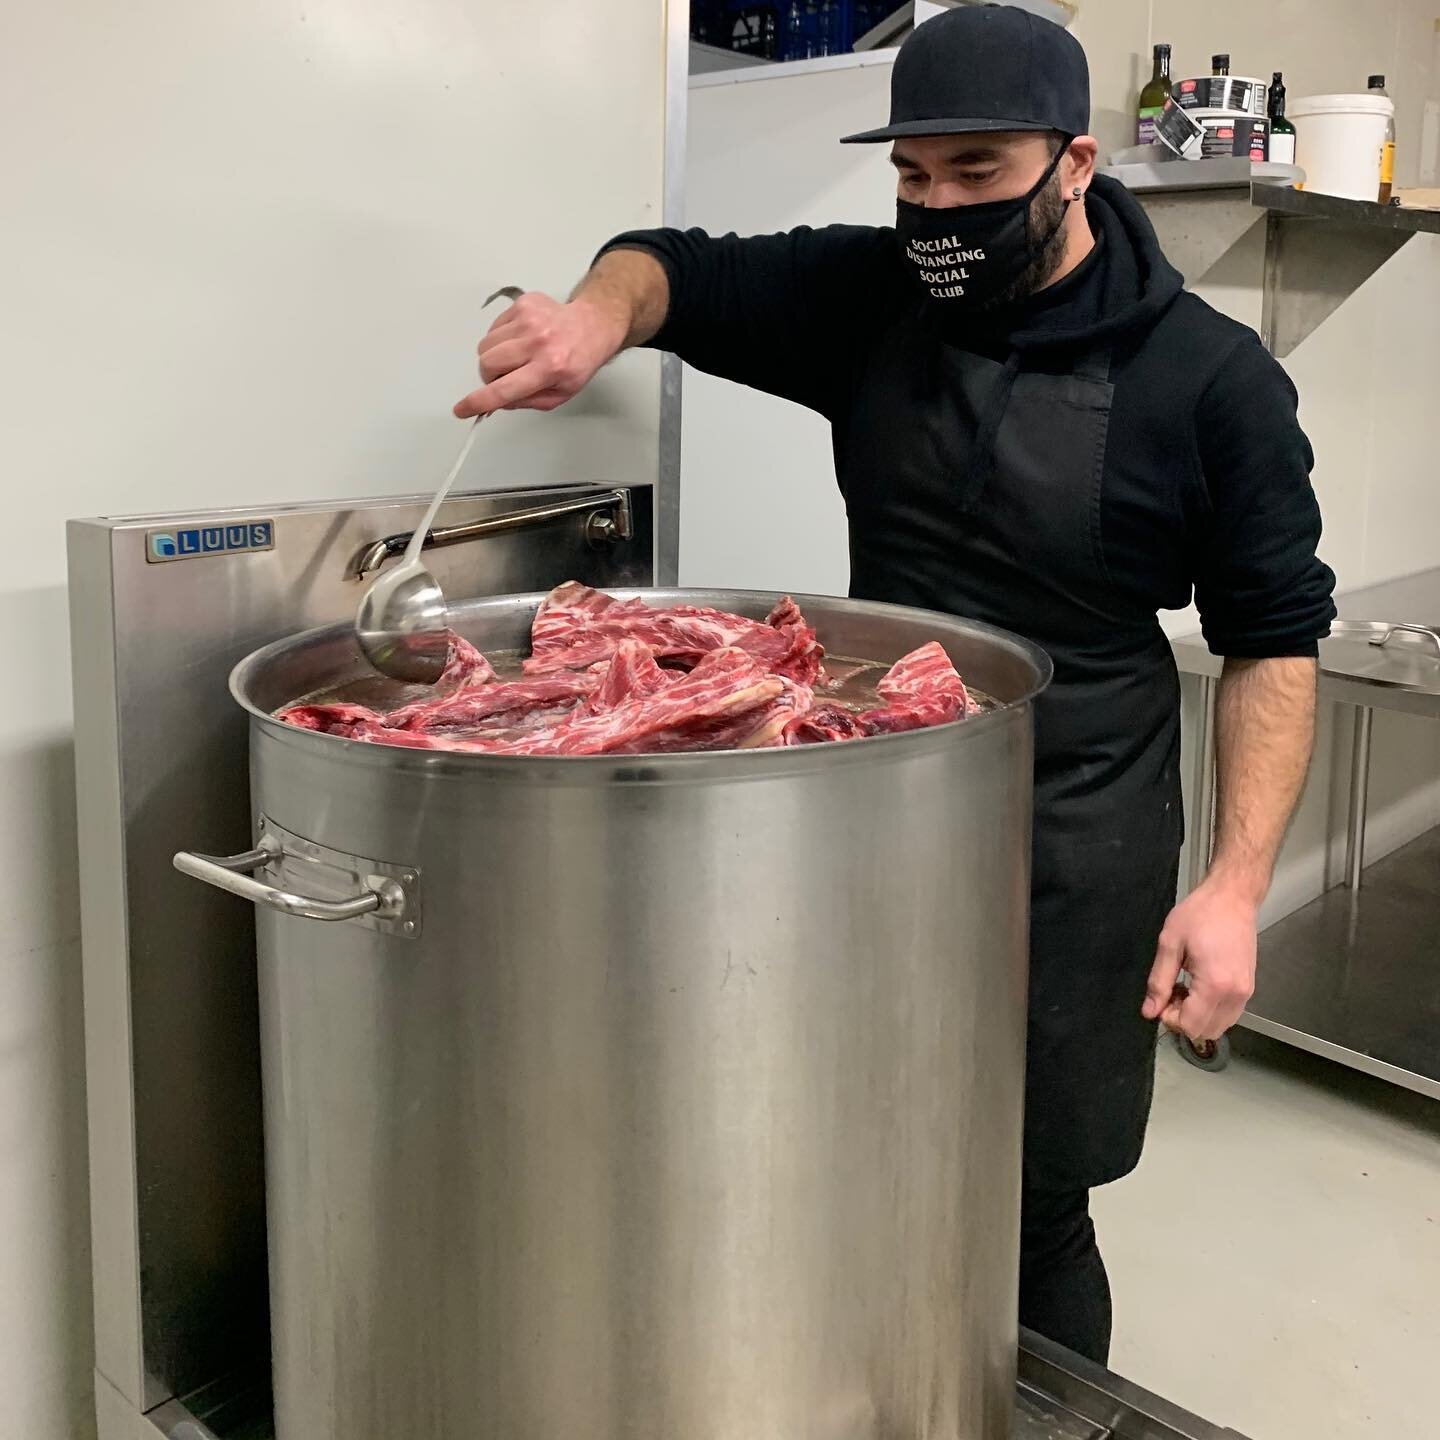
[1096,1034,1440,1440]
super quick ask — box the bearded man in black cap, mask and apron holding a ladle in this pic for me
[455,6,1333,1362]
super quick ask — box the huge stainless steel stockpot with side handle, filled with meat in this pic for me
[177,590,1050,1440]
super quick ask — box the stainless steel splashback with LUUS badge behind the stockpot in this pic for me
[69,485,654,1413]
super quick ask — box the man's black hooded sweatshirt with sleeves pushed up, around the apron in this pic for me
[606,179,1335,658]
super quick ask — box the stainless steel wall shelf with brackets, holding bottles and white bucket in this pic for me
[1104,158,1440,359]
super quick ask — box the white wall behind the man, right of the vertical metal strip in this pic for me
[681,0,1440,919]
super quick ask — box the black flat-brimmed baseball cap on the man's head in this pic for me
[841,4,1090,145]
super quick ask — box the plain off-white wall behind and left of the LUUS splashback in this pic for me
[0,0,664,1440]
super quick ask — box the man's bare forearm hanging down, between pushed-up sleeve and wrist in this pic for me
[1210,658,1316,904]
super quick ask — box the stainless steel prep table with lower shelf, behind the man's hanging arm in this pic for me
[1172,569,1440,1099]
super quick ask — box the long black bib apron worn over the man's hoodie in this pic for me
[837,318,1182,1189]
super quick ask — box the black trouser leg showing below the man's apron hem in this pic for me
[1020,1185,1110,1365]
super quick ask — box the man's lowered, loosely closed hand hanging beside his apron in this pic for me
[1142,880,1259,1041]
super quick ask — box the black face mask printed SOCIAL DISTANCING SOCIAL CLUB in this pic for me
[896,148,1070,311]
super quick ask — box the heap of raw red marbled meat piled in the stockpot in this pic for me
[279,583,978,755]
